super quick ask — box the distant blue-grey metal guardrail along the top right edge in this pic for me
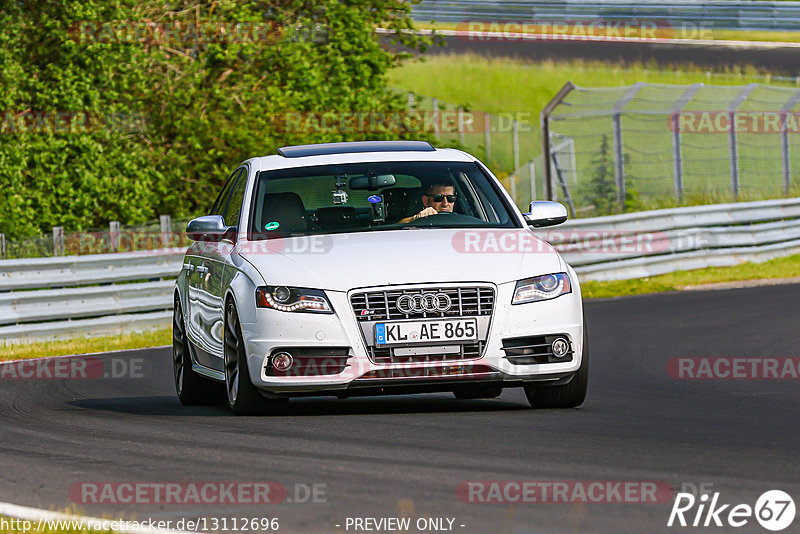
[411,0,800,31]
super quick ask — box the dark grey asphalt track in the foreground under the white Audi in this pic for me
[0,285,800,534]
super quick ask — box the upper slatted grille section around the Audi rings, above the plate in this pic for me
[350,286,494,321]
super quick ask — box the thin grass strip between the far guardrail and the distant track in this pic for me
[414,22,800,43]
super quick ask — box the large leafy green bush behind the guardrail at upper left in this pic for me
[0,0,428,237]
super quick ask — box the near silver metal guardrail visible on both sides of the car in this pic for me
[0,198,800,347]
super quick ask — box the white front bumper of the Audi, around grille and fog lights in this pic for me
[242,273,584,396]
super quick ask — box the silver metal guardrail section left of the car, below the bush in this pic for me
[0,249,185,349]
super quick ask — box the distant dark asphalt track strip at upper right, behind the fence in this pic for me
[426,36,800,76]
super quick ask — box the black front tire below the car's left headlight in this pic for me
[223,301,288,415]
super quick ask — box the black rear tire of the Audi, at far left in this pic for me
[172,297,221,406]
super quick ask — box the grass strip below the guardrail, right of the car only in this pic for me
[581,254,800,299]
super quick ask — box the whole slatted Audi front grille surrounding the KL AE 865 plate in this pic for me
[350,286,495,364]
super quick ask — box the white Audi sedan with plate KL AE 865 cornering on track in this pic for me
[173,141,589,414]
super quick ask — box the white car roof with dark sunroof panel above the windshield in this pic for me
[246,141,476,171]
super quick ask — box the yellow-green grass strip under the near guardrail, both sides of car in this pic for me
[0,254,800,360]
